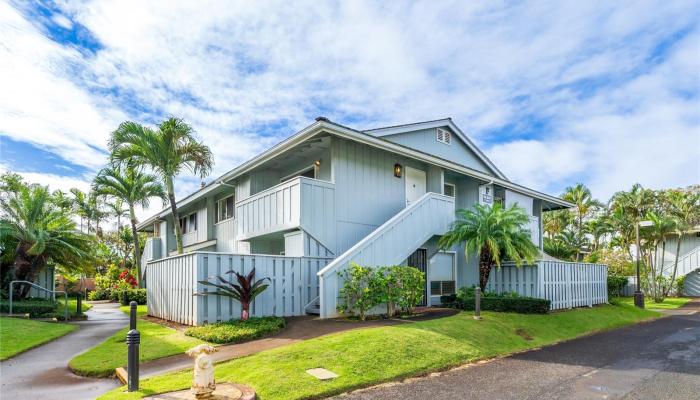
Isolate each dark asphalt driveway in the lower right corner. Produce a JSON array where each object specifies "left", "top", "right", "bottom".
[{"left": 341, "top": 300, "right": 700, "bottom": 400}]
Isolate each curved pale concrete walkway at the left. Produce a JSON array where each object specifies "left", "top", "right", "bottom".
[{"left": 0, "top": 303, "right": 129, "bottom": 400}]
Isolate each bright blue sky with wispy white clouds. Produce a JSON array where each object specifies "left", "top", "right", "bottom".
[{"left": 0, "top": 0, "right": 700, "bottom": 222}]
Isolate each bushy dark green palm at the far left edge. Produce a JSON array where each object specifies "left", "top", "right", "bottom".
[{"left": 0, "top": 185, "right": 92, "bottom": 299}]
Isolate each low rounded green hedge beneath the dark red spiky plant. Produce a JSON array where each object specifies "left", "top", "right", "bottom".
[{"left": 185, "top": 317, "right": 286, "bottom": 344}]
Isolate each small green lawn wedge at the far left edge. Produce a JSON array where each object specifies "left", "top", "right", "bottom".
[{"left": 0, "top": 318, "right": 76, "bottom": 360}]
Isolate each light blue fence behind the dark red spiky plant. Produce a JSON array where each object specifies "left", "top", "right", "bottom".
[{"left": 146, "top": 252, "right": 332, "bottom": 325}]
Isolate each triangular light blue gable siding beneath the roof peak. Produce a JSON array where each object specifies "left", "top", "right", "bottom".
[{"left": 382, "top": 127, "right": 494, "bottom": 174}]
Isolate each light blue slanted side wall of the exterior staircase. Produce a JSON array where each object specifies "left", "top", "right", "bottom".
[{"left": 318, "top": 193, "right": 455, "bottom": 318}]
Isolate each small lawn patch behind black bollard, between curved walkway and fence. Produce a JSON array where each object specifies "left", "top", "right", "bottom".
[{"left": 68, "top": 320, "right": 204, "bottom": 377}]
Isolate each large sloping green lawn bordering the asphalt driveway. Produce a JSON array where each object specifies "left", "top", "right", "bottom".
[{"left": 100, "top": 305, "right": 660, "bottom": 400}]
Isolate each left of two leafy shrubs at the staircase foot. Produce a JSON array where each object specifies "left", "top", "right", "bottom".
[{"left": 338, "top": 263, "right": 381, "bottom": 321}]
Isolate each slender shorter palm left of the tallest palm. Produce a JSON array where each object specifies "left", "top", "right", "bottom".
[{"left": 92, "top": 164, "right": 165, "bottom": 286}]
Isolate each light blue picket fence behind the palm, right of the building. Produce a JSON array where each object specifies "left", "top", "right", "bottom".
[{"left": 486, "top": 261, "right": 608, "bottom": 310}]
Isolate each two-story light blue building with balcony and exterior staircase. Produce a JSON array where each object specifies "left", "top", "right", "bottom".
[{"left": 138, "top": 117, "right": 607, "bottom": 324}]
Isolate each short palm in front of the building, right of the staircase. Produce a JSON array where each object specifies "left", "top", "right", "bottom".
[{"left": 438, "top": 203, "right": 539, "bottom": 290}]
